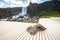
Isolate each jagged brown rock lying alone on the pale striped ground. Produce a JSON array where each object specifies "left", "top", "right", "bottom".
[{"left": 26, "top": 24, "right": 46, "bottom": 35}]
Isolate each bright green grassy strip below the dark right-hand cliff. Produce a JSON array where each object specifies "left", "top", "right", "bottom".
[{"left": 35, "top": 11, "right": 60, "bottom": 18}]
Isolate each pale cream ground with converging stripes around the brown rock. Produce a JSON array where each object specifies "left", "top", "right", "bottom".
[{"left": 0, "top": 19, "right": 60, "bottom": 40}]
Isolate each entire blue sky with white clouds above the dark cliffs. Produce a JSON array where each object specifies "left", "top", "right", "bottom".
[{"left": 0, "top": 0, "right": 48, "bottom": 8}]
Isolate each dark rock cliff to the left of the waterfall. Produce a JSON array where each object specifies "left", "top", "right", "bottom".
[{"left": 0, "top": 7, "right": 22, "bottom": 18}]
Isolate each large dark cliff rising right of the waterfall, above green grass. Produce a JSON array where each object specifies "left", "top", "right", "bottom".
[{"left": 27, "top": 1, "right": 60, "bottom": 16}]
